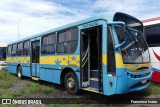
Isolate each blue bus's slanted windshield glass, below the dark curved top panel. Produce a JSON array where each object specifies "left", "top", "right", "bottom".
[{"left": 121, "top": 27, "right": 149, "bottom": 63}]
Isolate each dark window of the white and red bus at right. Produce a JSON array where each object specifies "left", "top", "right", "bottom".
[{"left": 145, "top": 25, "right": 160, "bottom": 47}]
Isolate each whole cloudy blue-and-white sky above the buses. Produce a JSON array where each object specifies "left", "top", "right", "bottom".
[{"left": 0, "top": 0, "right": 160, "bottom": 44}]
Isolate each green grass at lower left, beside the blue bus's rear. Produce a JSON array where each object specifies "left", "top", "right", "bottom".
[{"left": 0, "top": 69, "right": 54, "bottom": 98}]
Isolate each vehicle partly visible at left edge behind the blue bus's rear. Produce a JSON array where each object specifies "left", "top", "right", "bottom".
[{"left": 0, "top": 44, "right": 7, "bottom": 70}]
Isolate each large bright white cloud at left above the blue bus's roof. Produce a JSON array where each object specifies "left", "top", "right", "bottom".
[{"left": 0, "top": 0, "right": 90, "bottom": 42}]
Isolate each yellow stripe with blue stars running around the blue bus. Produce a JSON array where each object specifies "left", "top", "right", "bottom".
[{"left": 6, "top": 53, "right": 150, "bottom": 71}]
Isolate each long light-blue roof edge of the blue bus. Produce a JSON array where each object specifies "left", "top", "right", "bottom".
[{"left": 7, "top": 12, "right": 132, "bottom": 44}]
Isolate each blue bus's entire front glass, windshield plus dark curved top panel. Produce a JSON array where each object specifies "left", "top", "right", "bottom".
[{"left": 115, "top": 14, "right": 150, "bottom": 63}]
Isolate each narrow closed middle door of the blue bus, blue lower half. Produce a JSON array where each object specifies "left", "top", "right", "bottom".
[{"left": 31, "top": 40, "right": 40, "bottom": 77}]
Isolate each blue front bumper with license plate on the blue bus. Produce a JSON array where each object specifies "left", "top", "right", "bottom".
[{"left": 116, "top": 71, "right": 152, "bottom": 94}]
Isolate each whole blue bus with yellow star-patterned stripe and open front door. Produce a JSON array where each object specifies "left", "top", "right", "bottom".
[{"left": 7, "top": 12, "right": 152, "bottom": 96}]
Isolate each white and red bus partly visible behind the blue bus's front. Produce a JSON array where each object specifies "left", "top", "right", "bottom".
[{"left": 142, "top": 17, "right": 160, "bottom": 82}]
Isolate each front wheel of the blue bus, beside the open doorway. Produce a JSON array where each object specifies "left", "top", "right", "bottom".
[{"left": 64, "top": 72, "right": 79, "bottom": 95}]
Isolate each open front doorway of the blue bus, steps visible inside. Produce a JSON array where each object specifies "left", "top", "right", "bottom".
[{"left": 81, "top": 26, "right": 102, "bottom": 92}]
